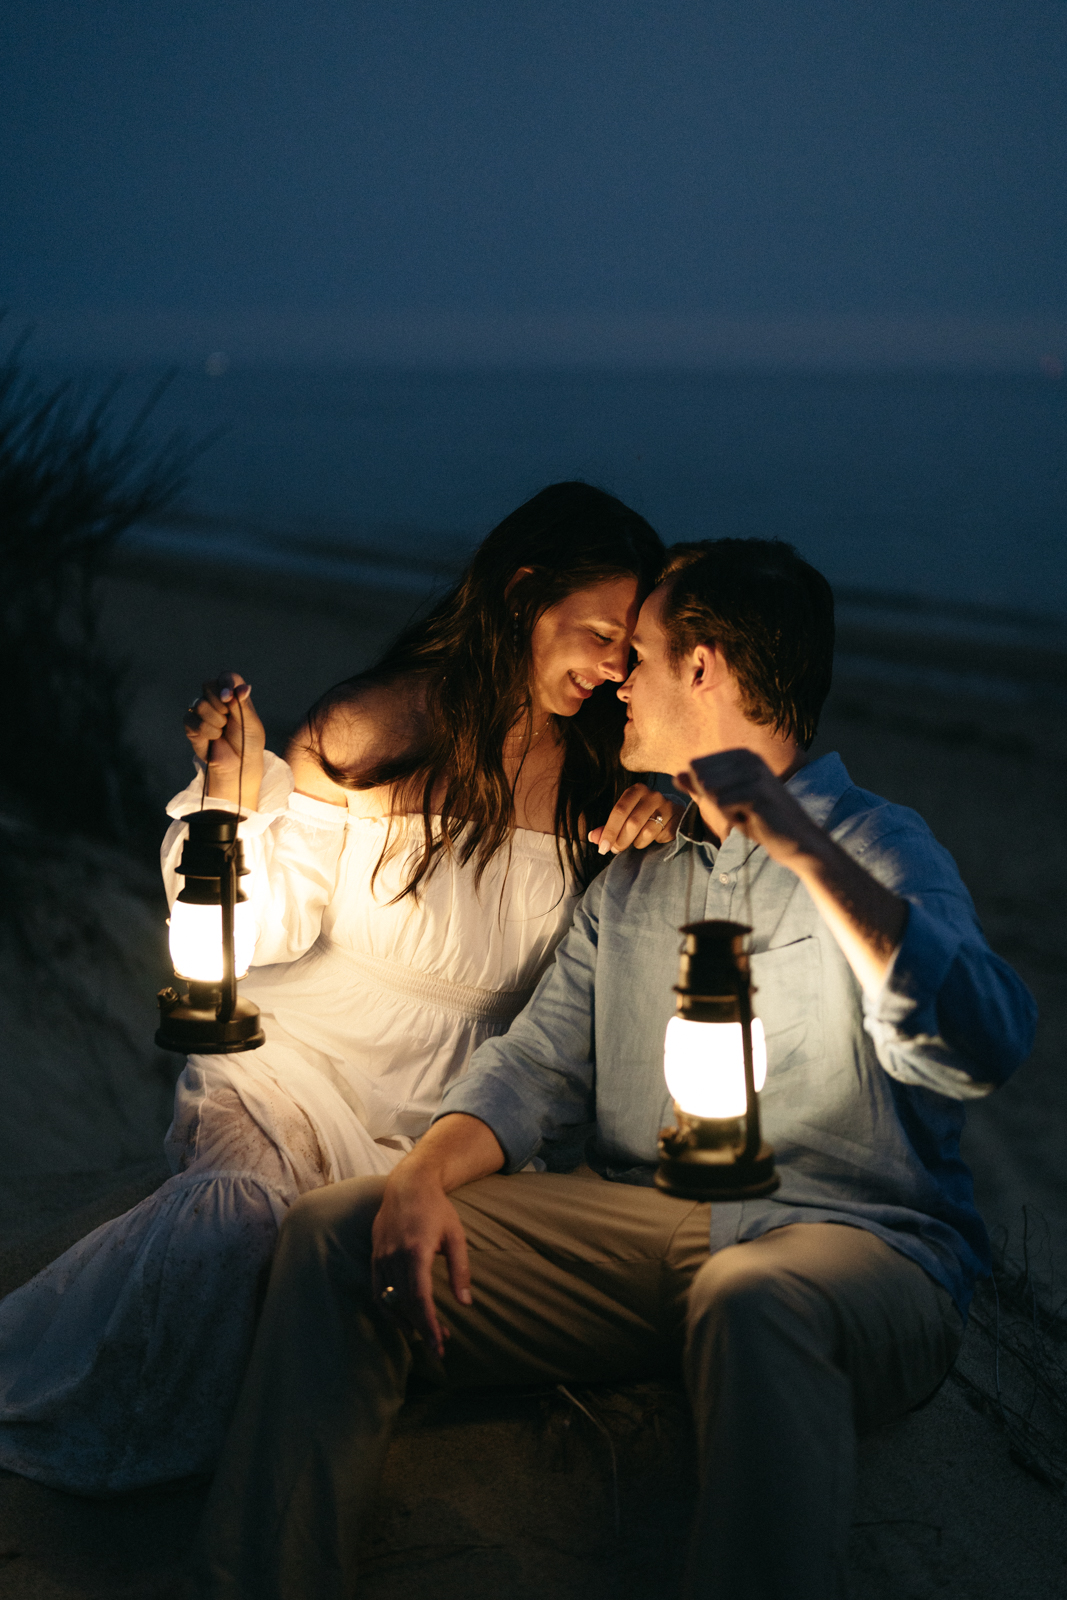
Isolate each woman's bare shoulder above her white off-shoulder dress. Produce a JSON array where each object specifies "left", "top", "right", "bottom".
[{"left": 286, "top": 677, "right": 426, "bottom": 805}]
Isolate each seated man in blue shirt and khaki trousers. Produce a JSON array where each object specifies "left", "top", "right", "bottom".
[{"left": 195, "top": 539, "right": 1033, "bottom": 1600}]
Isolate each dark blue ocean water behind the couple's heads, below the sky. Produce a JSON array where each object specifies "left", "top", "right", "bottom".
[{"left": 131, "top": 368, "right": 1067, "bottom": 634}]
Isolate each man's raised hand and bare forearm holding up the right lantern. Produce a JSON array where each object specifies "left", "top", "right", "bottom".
[{"left": 675, "top": 750, "right": 907, "bottom": 992}]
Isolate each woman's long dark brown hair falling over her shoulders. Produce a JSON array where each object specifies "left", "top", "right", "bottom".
[{"left": 309, "top": 483, "right": 665, "bottom": 898}]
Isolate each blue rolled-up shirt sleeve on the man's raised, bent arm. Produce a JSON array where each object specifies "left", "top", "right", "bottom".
[{"left": 846, "top": 827, "right": 1037, "bottom": 1099}]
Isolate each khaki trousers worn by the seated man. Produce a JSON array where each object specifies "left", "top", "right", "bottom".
[{"left": 200, "top": 1171, "right": 960, "bottom": 1600}]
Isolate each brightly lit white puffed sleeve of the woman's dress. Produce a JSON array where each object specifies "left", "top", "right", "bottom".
[{"left": 160, "top": 750, "right": 349, "bottom": 966}]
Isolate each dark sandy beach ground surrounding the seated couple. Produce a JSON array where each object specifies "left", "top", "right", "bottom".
[{"left": 0, "top": 566, "right": 1067, "bottom": 1600}]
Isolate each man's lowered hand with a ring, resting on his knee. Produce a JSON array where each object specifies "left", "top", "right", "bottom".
[{"left": 371, "top": 1112, "right": 504, "bottom": 1360}]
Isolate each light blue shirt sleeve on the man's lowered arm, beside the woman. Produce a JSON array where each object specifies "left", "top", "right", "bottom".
[{"left": 434, "top": 875, "right": 603, "bottom": 1173}]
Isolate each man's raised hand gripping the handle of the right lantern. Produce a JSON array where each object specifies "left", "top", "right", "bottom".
[{"left": 675, "top": 750, "right": 825, "bottom": 866}]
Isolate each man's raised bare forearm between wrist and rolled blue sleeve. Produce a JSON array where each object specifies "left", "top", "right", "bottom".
[{"left": 789, "top": 830, "right": 907, "bottom": 990}]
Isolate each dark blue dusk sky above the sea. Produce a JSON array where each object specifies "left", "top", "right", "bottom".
[{"left": 0, "top": 0, "right": 1067, "bottom": 366}]
